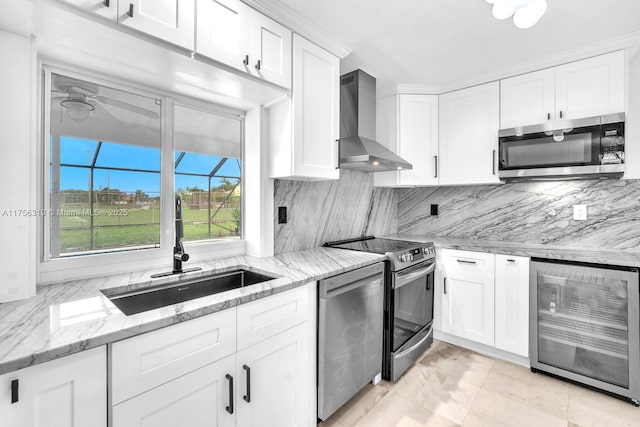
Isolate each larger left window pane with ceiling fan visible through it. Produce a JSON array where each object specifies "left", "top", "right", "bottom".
[{"left": 48, "top": 73, "right": 161, "bottom": 259}]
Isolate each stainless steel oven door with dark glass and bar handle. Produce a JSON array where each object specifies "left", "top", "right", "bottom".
[{"left": 389, "top": 260, "right": 435, "bottom": 381}]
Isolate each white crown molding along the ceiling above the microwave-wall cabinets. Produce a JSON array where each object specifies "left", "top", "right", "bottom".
[{"left": 440, "top": 31, "right": 640, "bottom": 94}]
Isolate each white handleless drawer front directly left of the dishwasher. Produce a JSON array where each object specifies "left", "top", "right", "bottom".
[{"left": 238, "top": 285, "right": 315, "bottom": 350}]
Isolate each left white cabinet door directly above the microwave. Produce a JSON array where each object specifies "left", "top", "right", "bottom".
[{"left": 500, "top": 68, "right": 555, "bottom": 129}]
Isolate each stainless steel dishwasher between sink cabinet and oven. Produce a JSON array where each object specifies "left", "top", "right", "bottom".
[{"left": 318, "top": 263, "right": 384, "bottom": 420}]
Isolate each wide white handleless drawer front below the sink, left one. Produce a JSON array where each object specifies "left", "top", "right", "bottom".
[{"left": 111, "top": 308, "right": 236, "bottom": 405}]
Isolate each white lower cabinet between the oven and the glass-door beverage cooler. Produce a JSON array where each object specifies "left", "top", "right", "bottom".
[{"left": 439, "top": 249, "right": 529, "bottom": 357}]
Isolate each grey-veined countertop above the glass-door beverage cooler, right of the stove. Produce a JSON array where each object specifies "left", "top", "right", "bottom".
[{"left": 385, "top": 234, "right": 640, "bottom": 267}]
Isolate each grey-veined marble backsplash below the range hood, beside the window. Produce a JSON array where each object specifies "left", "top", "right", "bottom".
[{"left": 274, "top": 170, "right": 398, "bottom": 254}]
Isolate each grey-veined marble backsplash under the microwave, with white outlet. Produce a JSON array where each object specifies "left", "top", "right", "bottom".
[{"left": 396, "top": 180, "right": 640, "bottom": 250}]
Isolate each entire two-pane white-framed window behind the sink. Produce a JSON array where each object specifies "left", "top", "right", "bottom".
[{"left": 40, "top": 66, "right": 244, "bottom": 274}]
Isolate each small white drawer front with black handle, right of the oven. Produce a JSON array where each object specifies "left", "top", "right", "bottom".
[{"left": 442, "top": 249, "right": 495, "bottom": 281}]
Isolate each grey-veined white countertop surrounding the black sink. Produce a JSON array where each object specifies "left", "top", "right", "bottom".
[{"left": 0, "top": 248, "right": 384, "bottom": 374}]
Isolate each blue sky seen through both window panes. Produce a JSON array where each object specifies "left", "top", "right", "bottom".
[{"left": 60, "top": 137, "right": 240, "bottom": 196}]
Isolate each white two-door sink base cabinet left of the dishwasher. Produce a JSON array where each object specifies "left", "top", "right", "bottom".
[{"left": 111, "top": 283, "right": 316, "bottom": 427}]
